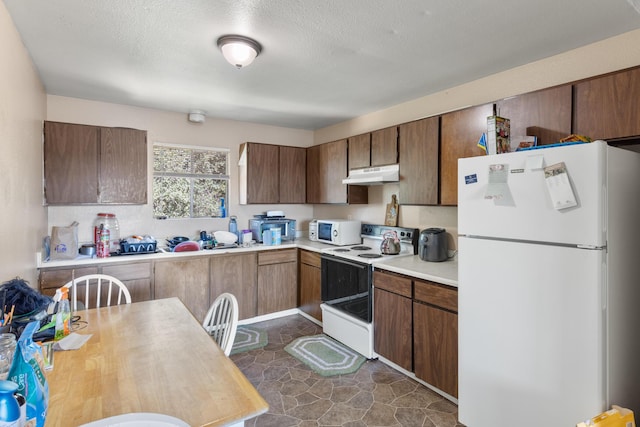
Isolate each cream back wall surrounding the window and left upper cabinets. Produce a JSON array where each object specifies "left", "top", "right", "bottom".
[{"left": 47, "top": 95, "right": 313, "bottom": 242}]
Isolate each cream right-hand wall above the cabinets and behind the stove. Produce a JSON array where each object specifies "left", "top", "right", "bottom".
[{"left": 314, "top": 30, "right": 640, "bottom": 246}]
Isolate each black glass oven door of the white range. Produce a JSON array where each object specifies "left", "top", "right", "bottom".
[{"left": 320, "top": 255, "right": 373, "bottom": 323}]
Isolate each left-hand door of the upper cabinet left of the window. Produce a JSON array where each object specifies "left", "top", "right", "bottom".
[{"left": 44, "top": 122, "right": 100, "bottom": 204}]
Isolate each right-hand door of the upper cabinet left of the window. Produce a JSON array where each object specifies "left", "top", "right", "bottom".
[{"left": 99, "top": 128, "right": 147, "bottom": 204}]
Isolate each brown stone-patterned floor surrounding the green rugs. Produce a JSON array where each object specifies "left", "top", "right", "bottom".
[{"left": 231, "top": 315, "right": 463, "bottom": 427}]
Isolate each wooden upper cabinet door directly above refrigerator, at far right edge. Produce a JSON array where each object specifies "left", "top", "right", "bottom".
[{"left": 573, "top": 68, "right": 640, "bottom": 139}]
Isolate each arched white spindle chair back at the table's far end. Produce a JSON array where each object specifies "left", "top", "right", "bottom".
[{"left": 64, "top": 274, "right": 131, "bottom": 311}]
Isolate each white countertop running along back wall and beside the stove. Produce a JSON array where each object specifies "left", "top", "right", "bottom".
[{"left": 36, "top": 237, "right": 458, "bottom": 287}]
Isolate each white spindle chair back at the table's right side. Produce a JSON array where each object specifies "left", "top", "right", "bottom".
[{"left": 202, "top": 293, "right": 238, "bottom": 356}]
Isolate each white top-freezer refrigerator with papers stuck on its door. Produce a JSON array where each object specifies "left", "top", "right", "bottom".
[{"left": 458, "top": 141, "right": 640, "bottom": 427}]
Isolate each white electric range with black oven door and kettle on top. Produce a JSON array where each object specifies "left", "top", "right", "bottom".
[{"left": 320, "top": 224, "right": 419, "bottom": 359}]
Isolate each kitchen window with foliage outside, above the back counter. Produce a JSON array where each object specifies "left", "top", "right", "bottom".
[{"left": 153, "top": 143, "right": 229, "bottom": 219}]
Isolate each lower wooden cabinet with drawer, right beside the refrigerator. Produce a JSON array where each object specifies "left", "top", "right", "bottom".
[{"left": 413, "top": 281, "right": 458, "bottom": 397}]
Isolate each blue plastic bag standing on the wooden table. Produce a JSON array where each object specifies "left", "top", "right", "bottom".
[{"left": 7, "top": 321, "right": 49, "bottom": 427}]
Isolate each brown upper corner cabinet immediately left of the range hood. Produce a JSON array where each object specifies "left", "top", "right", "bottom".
[{"left": 307, "top": 139, "right": 368, "bottom": 203}]
